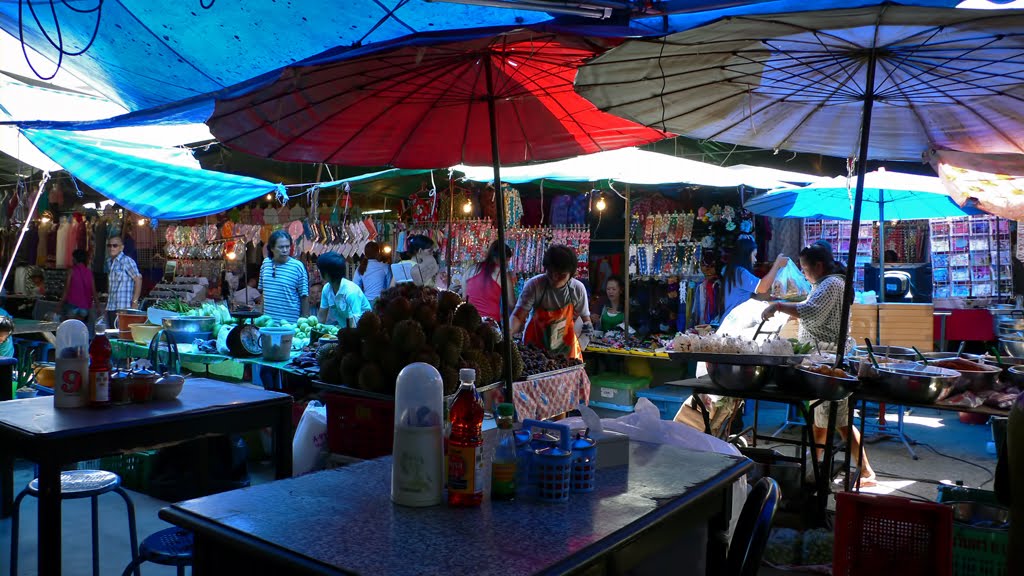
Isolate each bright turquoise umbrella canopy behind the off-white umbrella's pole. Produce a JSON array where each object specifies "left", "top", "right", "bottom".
[{"left": 743, "top": 171, "right": 980, "bottom": 221}]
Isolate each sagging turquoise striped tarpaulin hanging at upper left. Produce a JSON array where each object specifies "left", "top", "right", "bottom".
[{"left": 23, "top": 129, "right": 285, "bottom": 220}]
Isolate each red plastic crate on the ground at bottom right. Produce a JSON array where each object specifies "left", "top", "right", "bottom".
[{"left": 833, "top": 492, "right": 953, "bottom": 576}]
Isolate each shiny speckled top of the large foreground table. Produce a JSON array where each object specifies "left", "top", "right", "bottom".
[{"left": 161, "top": 443, "right": 753, "bottom": 576}]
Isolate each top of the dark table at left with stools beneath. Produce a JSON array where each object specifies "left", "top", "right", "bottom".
[{"left": 0, "top": 378, "right": 292, "bottom": 438}]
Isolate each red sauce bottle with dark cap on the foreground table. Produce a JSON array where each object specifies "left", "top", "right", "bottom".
[{"left": 445, "top": 368, "right": 483, "bottom": 506}]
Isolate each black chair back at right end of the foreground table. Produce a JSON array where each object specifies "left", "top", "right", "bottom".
[{"left": 725, "top": 477, "right": 780, "bottom": 576}]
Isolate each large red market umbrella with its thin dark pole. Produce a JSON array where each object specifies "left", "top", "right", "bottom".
[{"left": 208, "top": 30, "right": 666, "bottom": 398}]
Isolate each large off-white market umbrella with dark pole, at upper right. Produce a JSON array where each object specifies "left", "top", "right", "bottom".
[{"left": 577, "top": 4, "right": 1024, "bottom": 357}]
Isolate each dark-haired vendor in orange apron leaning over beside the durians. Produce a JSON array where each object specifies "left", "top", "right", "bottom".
[{"left": 510, "top": 244, "right": 594, "bottom": 360}]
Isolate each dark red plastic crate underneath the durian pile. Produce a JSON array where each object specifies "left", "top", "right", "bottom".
[{"left": 323, "top": 392, "right": 394, "bottom": 459}]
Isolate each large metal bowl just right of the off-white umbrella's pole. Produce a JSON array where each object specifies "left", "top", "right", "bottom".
[{"left": 861, "top": 363, "right": 961, "bottom": 404}]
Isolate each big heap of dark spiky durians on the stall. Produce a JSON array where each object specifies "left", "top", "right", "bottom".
[{"left": 317, "top": 284, "right": 523, "bottom": 395}]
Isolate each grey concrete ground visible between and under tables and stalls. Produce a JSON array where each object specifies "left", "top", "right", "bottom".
[{"left": 0, "top": 403, "right": 995, "bottom": 576}]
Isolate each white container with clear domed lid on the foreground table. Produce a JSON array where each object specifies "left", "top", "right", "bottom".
[{"left": 391, "top": 362, "right": 444, "bottom": 506}]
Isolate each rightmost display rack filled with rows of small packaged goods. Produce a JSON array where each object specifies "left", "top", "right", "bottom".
[{"left": 929, "top": 212, "right": 1013, "bottom": 299}]
